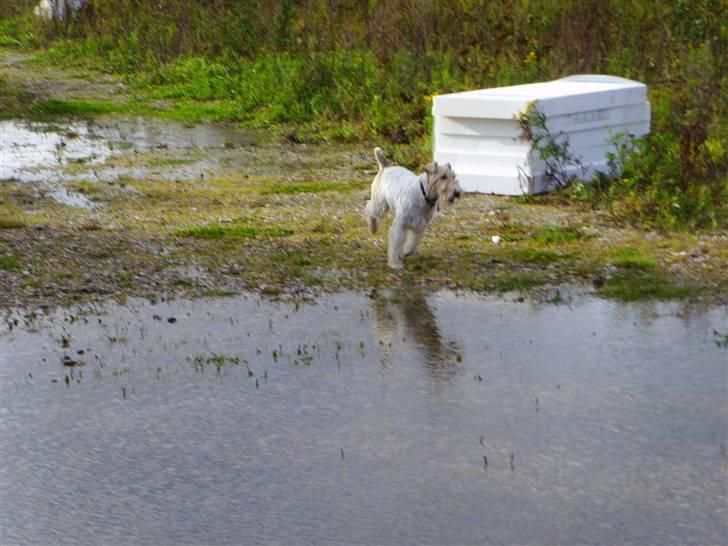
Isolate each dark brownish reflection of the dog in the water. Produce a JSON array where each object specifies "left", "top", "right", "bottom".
[{"left": 372, "top": 287, "right": 459, "bottom": 378}]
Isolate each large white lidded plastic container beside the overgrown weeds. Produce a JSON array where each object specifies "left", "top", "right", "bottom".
[{"left": 432, "top": 75, "right": 650, "bottom": 195}]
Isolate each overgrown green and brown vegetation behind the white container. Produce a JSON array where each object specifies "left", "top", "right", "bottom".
[{"left": 0, "top": 0, "right": 728, "bottom": 228}]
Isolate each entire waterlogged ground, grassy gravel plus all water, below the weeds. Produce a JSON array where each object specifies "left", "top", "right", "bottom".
[{"left": 0, "top": 41, "right": 728, "bottom": 544}]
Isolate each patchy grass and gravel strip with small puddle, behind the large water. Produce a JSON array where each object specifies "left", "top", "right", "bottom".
[{"left": 0, "top": 51, "right": 728, "bottom": 307}]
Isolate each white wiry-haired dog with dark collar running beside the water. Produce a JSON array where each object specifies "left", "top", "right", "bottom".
[{"left": 366, "top": 148, "right": 462, "bottom": 269}]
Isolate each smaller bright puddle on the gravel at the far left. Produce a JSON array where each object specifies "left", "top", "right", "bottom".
[{"left": 0, "top": 118, "right": 262, "bottom": 208}]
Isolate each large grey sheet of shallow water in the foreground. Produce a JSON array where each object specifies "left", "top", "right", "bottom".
[{"left": 0, "top": 291, "right": 728, "bottom": 544}]
